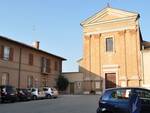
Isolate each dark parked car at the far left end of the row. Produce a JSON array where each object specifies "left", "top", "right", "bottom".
[{"left": 0, "top": 85, "right": 18, "bottom": 103}]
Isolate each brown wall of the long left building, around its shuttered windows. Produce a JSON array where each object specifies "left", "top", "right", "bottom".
[{"left": 0, "top": 39, "right": 62, "bottom": 88}]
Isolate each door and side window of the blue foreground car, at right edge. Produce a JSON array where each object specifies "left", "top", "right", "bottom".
[{"left": 135, "top": 89, "right": 150, "bottom": 113}]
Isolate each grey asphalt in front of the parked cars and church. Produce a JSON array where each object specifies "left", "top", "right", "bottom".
[{"left": 0, "top": 95, "right": 99, "bottom": 113}]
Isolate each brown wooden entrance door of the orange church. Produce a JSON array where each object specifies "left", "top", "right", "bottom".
[{"left": 105, "top": 73, "right": 116, "bottom": 89}]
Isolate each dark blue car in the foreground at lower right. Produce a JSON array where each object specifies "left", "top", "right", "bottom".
[{"left": 97, "top": 88, "right": 150, "bottom": 113}]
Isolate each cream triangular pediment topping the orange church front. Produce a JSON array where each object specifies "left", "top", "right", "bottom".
[{"left": 81, "top": 7, "right": 138, "bottom": 25}]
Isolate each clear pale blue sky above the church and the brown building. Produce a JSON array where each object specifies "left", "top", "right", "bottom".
[{"left": 0, "top": 0, "right": 150, "bottom": 72}]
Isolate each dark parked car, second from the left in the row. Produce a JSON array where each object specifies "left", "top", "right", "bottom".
[{"left": 17, "top": 89, "right": 32, "bottom": 101}]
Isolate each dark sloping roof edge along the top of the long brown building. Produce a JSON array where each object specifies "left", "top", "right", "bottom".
[{"left": 0, "top": 36, "right": 66, "bottom": 60}]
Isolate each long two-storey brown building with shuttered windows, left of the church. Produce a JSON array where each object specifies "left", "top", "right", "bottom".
[{"left": 0, "top": 36, "right": 65, "bottom": 88}]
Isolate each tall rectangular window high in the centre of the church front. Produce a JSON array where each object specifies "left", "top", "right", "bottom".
[{"left": 106, "top": 37, "right": 113, "bottom": 52}]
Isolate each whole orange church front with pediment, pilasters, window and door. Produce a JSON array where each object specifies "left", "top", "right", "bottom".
[{"left": 78, "top": 7, "right": 144, "bottom": 92}]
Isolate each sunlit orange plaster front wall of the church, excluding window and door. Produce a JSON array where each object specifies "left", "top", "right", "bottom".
[{"left": 79, "top": 7, "right": 143, "bottom": 90}]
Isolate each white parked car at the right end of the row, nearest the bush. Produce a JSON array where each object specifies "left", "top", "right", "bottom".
[{"left": 43, "top": 87, "right": 58, "bottom": 98}]
